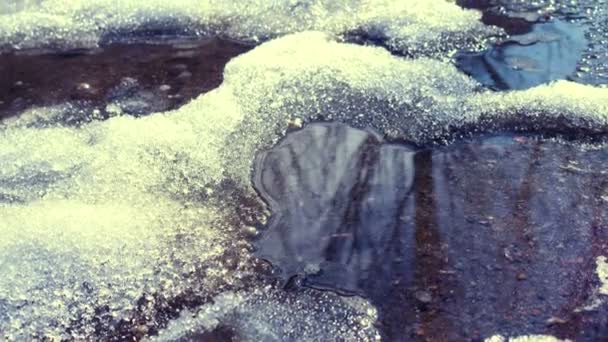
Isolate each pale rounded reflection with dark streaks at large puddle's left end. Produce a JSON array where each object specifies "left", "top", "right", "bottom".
[{"left": 256, "top": 124, "right": 413, "bottom": 295}]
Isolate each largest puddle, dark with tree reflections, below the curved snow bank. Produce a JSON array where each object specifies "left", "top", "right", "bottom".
[{"left": 254, "top": 123, "right": 608, "bottom": 341}]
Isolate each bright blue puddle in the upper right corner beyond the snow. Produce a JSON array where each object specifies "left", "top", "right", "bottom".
[{"left": 457, "top": 0, "right": 608, "bottom": 85}]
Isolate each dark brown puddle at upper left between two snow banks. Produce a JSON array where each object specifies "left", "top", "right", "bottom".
[{"left": 0, "top": 38, "right": 251, "bottom": 121}]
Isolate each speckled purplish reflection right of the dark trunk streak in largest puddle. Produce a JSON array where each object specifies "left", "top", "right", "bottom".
[{"left": 433, "top": 137, "right": 608, "bottom": 338}]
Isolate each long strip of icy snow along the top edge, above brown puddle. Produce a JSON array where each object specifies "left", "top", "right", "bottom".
[{"left": 0, "top": 0, "right": 498, "bottom": 54}]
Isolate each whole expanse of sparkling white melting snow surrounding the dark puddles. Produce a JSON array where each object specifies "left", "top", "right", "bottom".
[{"left": 0, "top": 0, "right": 608, "bottom": 340}]
